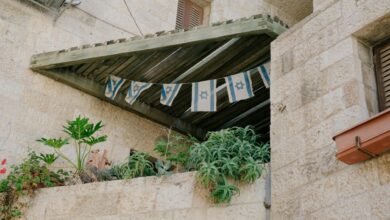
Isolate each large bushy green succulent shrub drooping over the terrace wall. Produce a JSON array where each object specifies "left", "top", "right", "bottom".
[{"left": 187, "top": 127, "right": 270, "bottom": 203}]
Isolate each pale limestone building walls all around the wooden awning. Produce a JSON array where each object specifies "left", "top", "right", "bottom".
[{"left": 0, "top": 0, "right": 390, "bottom": 220}]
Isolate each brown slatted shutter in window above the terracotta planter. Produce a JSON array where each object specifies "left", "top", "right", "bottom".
[{"left": 374, "top": 39, "right": 390, "bottom": 111}]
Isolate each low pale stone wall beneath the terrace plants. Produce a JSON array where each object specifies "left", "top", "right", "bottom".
[{"left": 26, "top": 173, "right": 265, "bottom": 220}]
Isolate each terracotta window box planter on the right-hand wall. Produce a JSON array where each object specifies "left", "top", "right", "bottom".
[{"left": 333, "top": 109, "right": 390, "bottom": 164}]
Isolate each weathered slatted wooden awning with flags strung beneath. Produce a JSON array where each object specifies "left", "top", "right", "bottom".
[{"left": 31, "top": 15, "right": 285, "bottom": 137}]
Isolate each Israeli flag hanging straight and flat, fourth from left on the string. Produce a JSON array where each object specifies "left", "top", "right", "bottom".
[{"left": 191, "top": 79, "right": 217, "bottom": 112}]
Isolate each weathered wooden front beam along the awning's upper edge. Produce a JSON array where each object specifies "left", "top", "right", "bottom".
[{"left": 30, "top": 16, "right": 285, "bottom": 70}]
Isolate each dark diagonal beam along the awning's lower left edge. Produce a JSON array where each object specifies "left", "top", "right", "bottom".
[{"left": 37, "top": 70, "right": 206, "bottom": 138}]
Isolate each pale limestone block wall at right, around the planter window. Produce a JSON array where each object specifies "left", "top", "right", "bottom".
[{"left": 271, "top": 0, "right": 390, "bottom": 220}]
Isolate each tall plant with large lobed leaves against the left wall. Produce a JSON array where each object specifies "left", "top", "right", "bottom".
[{"left": 38, "top": 116, "right": 107, "bottom": 175}]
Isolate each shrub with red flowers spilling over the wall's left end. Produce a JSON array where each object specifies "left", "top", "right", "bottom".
[{"left": 0, "top": 152, "right": 69, "bottom": 220}]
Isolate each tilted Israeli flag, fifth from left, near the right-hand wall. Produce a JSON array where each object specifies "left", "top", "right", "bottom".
[{"left": 225, "top": 72, "right": 254, "bottom": 103}]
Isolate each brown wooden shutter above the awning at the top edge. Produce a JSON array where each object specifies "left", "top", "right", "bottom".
[{"left": 176, "top": 0, "right": 203, "bottom": 29}]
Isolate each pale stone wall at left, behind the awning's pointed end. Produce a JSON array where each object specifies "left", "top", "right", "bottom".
[{"left": 0, "top": 0, "right": 176, "bottom": 164}]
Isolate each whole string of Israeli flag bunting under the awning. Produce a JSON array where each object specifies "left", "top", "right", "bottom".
[{"left": 105, "top": 62, "right": 270, "bottom": 112}]
